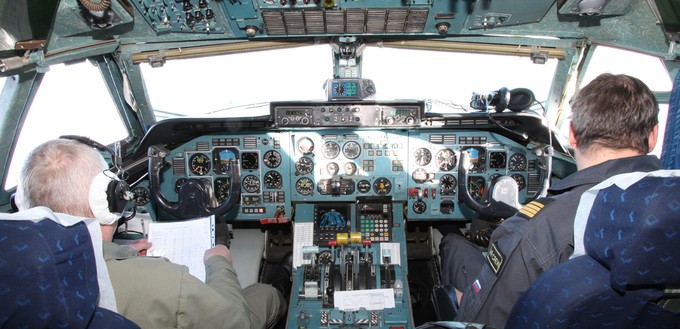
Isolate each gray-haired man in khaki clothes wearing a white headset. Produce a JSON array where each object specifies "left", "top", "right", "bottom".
[{"left": 16, "top": 139, "right": 286, "bottom": 329}]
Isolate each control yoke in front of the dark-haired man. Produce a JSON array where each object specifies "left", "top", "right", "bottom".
[{"left": 458, "top": 145, "right": 553, "bottom": 220}]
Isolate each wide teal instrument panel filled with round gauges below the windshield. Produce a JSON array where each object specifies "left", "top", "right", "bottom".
[{"left": 154, "top": 127, "right": 541, "bottom": 221}]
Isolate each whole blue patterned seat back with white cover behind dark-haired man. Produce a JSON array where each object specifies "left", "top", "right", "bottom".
[{"left": 506, "top": 171, "right": 680, "bottom": 328}]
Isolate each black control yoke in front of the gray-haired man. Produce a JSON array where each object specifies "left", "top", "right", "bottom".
[{"left": 148, "top": 146, "right": 241, "bottom": 219}]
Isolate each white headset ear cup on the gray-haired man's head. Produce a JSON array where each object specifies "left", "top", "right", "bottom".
[{"left": 89, "top": 170, "right": 122, "bottom": 225}]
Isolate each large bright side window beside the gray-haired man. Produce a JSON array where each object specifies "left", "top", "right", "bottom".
[{"left": 0, "top": 61, "right": 128, "bottom": 190}]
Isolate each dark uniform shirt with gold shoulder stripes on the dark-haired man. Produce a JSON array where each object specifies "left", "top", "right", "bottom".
[{"left": 456, "top": 156, "right": 661, "bottom": 328}]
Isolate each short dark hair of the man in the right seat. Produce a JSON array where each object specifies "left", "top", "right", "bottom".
[{"left": 569, "top": 73, "right": 659, "bottom": 154}]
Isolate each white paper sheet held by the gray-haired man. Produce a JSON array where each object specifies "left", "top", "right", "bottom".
[{"left": 147, "top": 216, "right": 215, "bottom": 282}]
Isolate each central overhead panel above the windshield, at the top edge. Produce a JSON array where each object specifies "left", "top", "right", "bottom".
[{"left": 223, "top": 0, "right": 467, "bottom": 38}]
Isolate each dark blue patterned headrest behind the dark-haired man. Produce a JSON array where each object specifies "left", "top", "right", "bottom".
[{"left": 583, "top": 175, "right": 680, "bottom": 292}]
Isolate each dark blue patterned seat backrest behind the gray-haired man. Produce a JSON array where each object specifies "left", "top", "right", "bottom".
[{"left": 0, "top": 219, "right": 139, "bottom": 328}]
